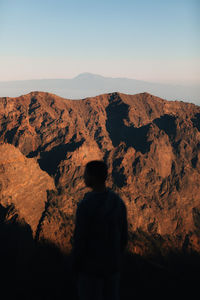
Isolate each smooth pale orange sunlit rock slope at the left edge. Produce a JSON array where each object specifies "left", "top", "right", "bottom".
[{"left": 0, "top": 144, "right": 55, "bottom": 236}]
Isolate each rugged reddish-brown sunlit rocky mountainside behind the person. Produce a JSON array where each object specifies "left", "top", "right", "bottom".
[{"left": 0, "top": 92, "right": 200, "bottom": 254}]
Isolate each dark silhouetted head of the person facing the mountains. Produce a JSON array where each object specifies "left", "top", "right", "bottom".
[{"left": 84, "top": 160, "right": 108, "bottom": 188}]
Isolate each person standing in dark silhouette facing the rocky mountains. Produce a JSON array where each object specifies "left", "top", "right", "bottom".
[{"left": 73, "top": 161, "right": 128, "bottom": 300}]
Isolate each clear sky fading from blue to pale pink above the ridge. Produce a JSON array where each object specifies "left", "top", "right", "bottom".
[{"left": 0, "top": 0, "right": 200, "bottom": 84}]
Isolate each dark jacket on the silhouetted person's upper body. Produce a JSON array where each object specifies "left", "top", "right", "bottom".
[{"left": 73, "top": 190, "right": 128, "bottom": 276}]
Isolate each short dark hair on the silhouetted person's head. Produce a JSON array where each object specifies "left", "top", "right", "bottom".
[{"left": 85, "top": 160, "right": 108, "bottom": 183}]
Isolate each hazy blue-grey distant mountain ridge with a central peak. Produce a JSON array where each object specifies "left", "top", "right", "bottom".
[{"left": 0, "top": 73, "right": 200, "bottom": 105}]
